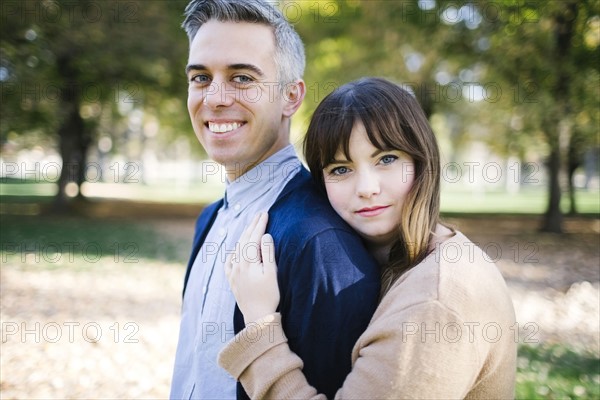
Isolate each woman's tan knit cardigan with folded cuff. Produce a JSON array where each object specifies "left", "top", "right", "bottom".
[{"left": 219, "top": 232, "right": 518, "bottom": 399}]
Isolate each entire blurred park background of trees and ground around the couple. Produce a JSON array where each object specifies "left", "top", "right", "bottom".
[{"left": 0, "top": 0, "right": 600, "bottom": 399}]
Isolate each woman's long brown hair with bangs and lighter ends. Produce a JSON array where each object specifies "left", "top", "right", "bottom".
[{"left": 304, "top": 78, "right": 440, "bottom": 295}]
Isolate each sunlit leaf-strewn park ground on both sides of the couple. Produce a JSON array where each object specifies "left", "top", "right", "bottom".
[{"left": 0, "top": 215, "right": 600, "bottom": 399}]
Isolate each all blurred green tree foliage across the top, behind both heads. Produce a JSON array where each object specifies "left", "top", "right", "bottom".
[{"left": 0, "top": 0, "right": 600, "bottom": 222}]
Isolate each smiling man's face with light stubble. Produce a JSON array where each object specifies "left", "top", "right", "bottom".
[{"left": 187, "top": 20, "right": 295, "bottom": 180}]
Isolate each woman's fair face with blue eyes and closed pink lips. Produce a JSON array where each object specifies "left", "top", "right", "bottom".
[{"left": 323, "top": 121, "right": 414, "bottom": 245}]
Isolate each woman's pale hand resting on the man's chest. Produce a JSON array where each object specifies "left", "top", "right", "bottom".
[{"left": 225, "top": 213, "right": 279, "bottom": 325}]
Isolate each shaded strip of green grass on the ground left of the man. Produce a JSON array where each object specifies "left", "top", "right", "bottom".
[{"left": 0, "top": 215, "right": 191, "bottom": 269}]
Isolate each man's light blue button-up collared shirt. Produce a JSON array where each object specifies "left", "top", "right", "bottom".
[{"left": 170, "top": 145, "right": 301, "bottom": 399}]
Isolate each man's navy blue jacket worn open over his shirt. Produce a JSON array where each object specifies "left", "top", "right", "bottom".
[{"left": 184, "top": 168, "right": 380, "bottom": 399}]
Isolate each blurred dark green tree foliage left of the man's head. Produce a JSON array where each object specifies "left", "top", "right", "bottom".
[{"left": 0, "top": 0, "right": 187, "bottom": 148}]
